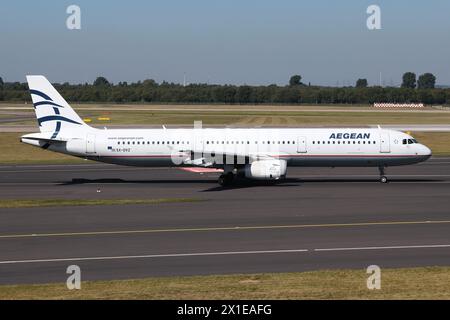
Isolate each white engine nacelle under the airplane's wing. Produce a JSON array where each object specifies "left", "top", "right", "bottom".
[{"left": 245, "top": 160, "right": 287, "bottom": 180}]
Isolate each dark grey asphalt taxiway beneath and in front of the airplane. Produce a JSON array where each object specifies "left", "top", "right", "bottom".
[{"left": 0, "top": 158, "right": 450, "bottom": 284}]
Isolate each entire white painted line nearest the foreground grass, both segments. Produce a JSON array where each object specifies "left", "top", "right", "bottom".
[{"left": 0, "top": 244, "right": 450, "bottom": 265}]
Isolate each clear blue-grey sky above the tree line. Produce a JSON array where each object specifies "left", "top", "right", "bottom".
[{"left": 0, "top": 0, "right": 450, "bottom": 86}]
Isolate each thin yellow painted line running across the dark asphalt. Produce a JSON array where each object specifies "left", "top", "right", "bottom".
[{"left": 0, "top": 220, "right": 450, "bottom": 239}]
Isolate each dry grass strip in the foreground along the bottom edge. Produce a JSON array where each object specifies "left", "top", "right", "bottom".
[{"left": 0, "top": 267, "right": 450, "bottom": 299}]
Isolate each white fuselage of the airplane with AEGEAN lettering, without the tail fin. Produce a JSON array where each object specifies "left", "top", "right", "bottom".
[{"left": 43, "top": 128, "right": 431, "bottom": 167}]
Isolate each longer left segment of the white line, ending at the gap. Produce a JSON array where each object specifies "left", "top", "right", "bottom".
[{"left": 0, "top": 249, "right": 309, "bottom": 264}]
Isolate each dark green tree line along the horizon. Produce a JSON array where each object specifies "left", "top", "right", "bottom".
[{"left": 0, "top": 72, "right": 450, "bottom": 104}]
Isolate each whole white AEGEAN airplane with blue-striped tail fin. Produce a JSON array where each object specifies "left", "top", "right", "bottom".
[{"left": 21, "top": 75, "right": 431, "bottom": 186}]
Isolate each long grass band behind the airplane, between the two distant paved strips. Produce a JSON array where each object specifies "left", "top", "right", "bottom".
[{"left": 8, "top": 110, "right": 450, "bottom": 127}]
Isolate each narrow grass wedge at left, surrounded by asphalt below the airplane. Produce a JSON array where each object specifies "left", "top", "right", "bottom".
[{"left": 0, "top": 198, "right": 204, "bottom": 208}]
